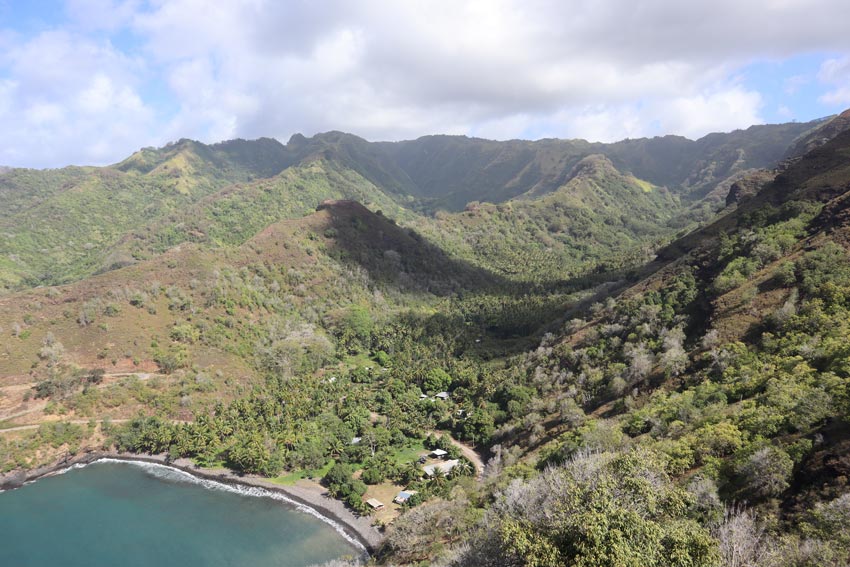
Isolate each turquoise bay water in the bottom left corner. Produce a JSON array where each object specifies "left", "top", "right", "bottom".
[{"left": 0, "top": 462, "right": 360, "bottom": 567}]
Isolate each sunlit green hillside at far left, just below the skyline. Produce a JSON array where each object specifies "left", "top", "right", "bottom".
[{"left": 0, "top": 140, "right": 292, "bottom": 288}]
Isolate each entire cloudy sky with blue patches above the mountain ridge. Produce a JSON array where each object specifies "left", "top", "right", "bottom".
[{"left": 0, "top": 0, "right": 850, "bottom": 168}]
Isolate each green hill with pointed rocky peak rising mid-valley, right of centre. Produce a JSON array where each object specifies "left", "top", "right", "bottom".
[{"left": 414, "top": 155, "right": 681, "bottom": 283}]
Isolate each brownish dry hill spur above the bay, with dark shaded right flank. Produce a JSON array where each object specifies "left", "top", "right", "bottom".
[{"left": 0, "top": 201, "right": 490, "bottom": 425}]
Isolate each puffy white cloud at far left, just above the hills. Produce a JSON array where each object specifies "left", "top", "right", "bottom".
[{"left": 0, "top": 31, "right": 155, "bottom": 166}]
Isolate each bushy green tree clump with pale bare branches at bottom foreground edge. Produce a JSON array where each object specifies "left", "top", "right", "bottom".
[{"left": 455, "top": 451, "right": 718, "bottom": 567}]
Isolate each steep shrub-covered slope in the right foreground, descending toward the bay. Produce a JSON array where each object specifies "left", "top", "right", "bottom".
[{"left": 418, "top": 112, "right": 850, "bottom": 567}]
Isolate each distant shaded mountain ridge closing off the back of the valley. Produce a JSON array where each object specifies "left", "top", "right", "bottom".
[{"left": 296, "top": 117, "right": 823, "bottom": 211}]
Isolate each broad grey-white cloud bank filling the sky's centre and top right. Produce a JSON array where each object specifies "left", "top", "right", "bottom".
[{"left": 126, "top": 0, "right": 850, "bottom": 146}]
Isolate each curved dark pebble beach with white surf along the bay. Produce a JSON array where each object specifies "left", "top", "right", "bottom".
[{"left": 0, "top": 451, "right": 384, "bottom": 554}]
